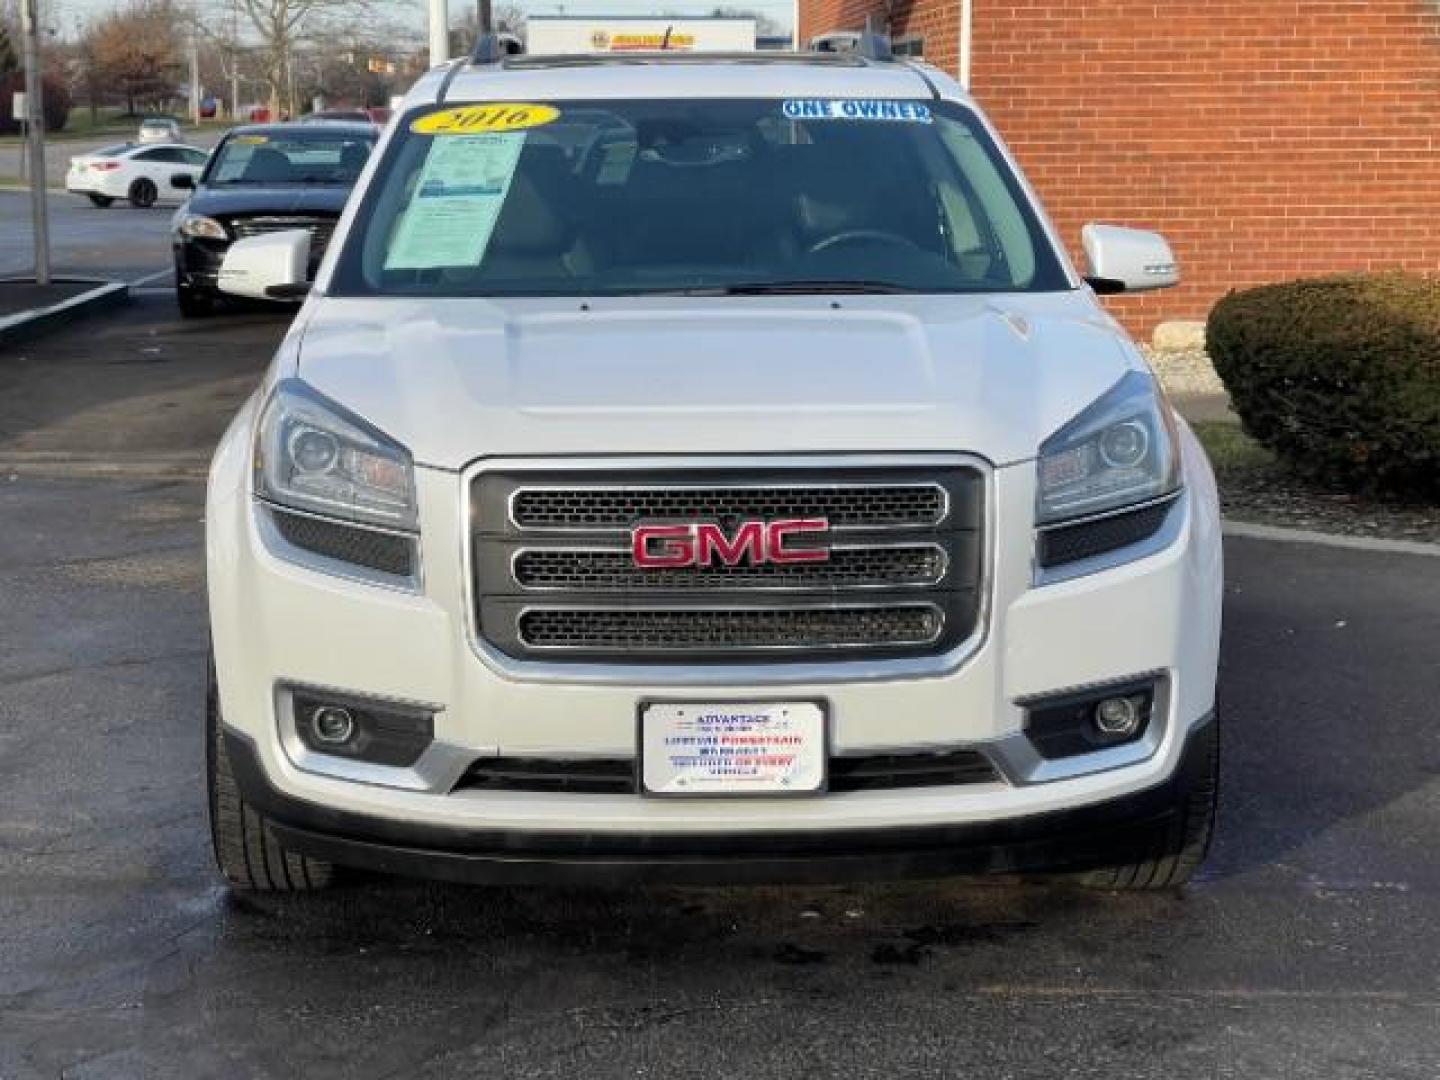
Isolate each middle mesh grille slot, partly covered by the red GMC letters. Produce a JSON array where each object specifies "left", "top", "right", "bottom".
[{"left": 514, "top": 544, "right": 945, "bottom": 592}]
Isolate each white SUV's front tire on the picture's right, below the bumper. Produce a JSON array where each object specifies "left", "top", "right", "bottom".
[{"left": 1076, "top": 713, "right": 1220, "bottom": 891}]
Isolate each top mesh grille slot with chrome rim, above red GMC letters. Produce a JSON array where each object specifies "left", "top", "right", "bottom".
[{"left": 513, "top": 484, "right": 946, "bottom": 528}]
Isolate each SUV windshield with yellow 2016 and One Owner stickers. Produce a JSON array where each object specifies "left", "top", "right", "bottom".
[{"left": 330, "top": 99, "right": 1070, "bottom": 297}]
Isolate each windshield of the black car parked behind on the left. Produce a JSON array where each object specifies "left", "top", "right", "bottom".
[{"left": 204, "top": 128, "right": 374, "bottom": 187}]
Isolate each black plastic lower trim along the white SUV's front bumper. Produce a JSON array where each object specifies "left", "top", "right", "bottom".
[{"left": 225, "top": 717, "right": 1215, "bottom": 884}]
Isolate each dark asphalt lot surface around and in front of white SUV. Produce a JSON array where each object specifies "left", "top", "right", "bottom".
[{"left": 0, "top": 295, "right": 1440, "bottom": 1079}]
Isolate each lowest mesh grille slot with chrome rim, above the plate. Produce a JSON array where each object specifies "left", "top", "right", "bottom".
[{"left": 520, "top": 603, "right": 945, "bottom": 652}]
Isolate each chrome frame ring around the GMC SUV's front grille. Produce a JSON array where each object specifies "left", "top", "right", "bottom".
[{"left": 455, "top": 452, "right": 996, "bottom": 687}]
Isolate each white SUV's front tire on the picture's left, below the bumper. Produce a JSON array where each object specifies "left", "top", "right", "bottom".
[{"left": 204, "top": 655, "right": 336, "bottom": 893}]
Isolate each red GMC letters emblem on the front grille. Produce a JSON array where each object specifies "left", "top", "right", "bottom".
[{"left": 631, "top": 517, "right": 829, "bottom": 569}]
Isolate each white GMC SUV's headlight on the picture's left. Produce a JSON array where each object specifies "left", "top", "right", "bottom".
[{"left": 255, "top": 379, "right": 419, "bottom": 530}]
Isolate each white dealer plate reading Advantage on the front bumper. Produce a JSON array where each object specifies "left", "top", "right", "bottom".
[{"left": 639, "top": 701, "right": 827, "bottom": 796}]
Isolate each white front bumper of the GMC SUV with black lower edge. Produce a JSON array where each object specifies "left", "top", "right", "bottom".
[{"left": 207, "top": 406, "right": 1220, "bottom": 880}]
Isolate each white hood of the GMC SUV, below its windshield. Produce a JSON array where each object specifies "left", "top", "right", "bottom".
[{"left": 298, "top": 291, "right": 1142, "bottom": 469}]
